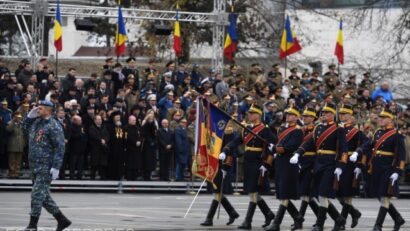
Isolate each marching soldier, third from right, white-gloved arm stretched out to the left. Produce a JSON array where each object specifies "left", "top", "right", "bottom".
[{"left": 290, "top": 103, "right": 348, "bottom": 231}]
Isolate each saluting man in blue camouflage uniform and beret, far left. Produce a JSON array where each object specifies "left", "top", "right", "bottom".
[{"left": 23, "top": 101, "right": 71, "bottom": 231}]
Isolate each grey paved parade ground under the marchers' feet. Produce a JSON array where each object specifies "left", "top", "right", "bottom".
[{"left": 0, "top": 192, "right": 410, "bottom": 230}]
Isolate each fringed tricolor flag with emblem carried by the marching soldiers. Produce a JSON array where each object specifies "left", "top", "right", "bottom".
[{"left": 192, "top": 98, "right": 231, "bottom": 188}]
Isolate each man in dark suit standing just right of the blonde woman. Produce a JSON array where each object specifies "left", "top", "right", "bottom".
[{"left": 158, "top": 119, "right": 174, "bottom": 181}]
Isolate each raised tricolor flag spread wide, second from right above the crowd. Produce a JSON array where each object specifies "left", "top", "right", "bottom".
[{"left": 279, "top": 16, "right": 302, "bottom": 59}]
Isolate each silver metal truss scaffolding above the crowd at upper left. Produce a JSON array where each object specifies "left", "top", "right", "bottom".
[{"left": 0, "top": 0, "right": 228, "bottom": 72}]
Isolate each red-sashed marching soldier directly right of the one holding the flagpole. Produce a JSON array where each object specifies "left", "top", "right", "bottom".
[{"left": 266, "top": 107, "right": 303, "bottom": 231}]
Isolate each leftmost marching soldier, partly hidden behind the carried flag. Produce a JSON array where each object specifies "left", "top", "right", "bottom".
[{"left": 201, "top": 123, "right": 239, "bottom": 226}]
